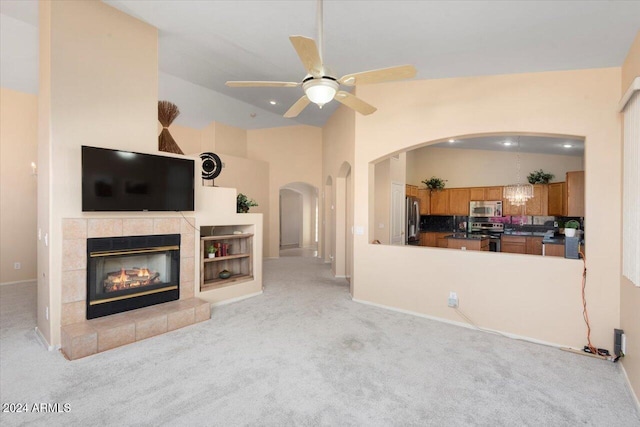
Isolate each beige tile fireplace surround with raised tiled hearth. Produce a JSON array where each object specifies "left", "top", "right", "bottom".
[{"left": 61, "top": 218, "right": 211, "bottom": 360}]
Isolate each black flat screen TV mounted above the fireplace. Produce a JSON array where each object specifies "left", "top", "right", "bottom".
[{"left": 82, "top": 146, "right": 194, "bottom": 212}]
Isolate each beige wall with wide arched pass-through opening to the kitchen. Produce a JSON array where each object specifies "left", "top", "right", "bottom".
[{"left": 352, "top": 68, "right": 621, "bottom": 348}]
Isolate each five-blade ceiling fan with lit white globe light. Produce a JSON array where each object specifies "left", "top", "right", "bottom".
[{"left": 226, "top": 0, "right": 416, "bottom": 118}]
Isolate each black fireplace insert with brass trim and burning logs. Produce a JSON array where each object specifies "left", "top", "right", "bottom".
[{"left": 87, "top": 234, "right": 180, "bottom": 319}]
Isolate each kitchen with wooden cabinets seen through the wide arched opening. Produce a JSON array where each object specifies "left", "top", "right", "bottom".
[{"left": 378, "top": 135, "right": 585, "bottom": 259}]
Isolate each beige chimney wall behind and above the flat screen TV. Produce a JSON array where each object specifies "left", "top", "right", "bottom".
[{"left": 38, "top": 1, "right": 158, "bottom": 345}]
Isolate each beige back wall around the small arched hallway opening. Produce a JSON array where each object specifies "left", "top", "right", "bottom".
[{"left": 247, "top": 126, "right": 322, "bottom": 258}]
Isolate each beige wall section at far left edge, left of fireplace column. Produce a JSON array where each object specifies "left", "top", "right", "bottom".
[{"left": 0, "top": 88, "right": 38, "bottom": 284}]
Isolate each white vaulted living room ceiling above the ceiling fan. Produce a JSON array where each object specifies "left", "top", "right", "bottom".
[{"left": 0, "top": 0, "right": 640, "bottom": 129}]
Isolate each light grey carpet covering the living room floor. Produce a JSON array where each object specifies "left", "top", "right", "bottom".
[{"left": 0, "top": 257, "right": 640, "bottom": 426}]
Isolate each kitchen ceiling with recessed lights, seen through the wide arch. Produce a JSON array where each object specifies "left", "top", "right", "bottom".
[{"left": 430, "top": 134, "right": 584, "bottom": 157}]
